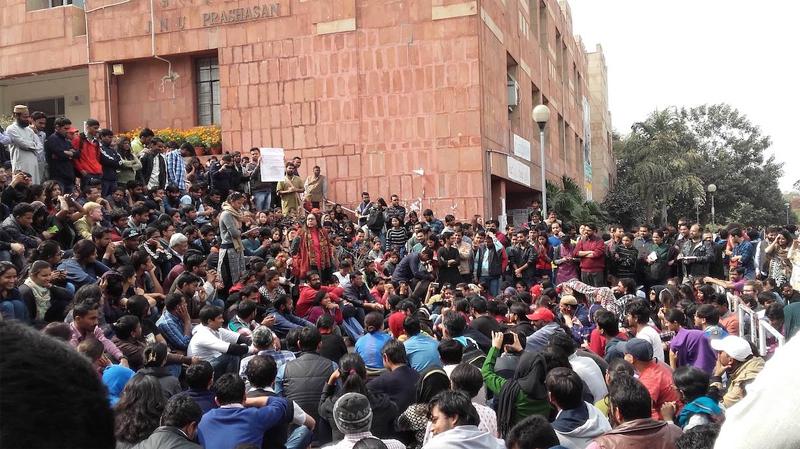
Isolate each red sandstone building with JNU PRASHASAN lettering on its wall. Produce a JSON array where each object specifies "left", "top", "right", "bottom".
[{"left": 0, "top": 0, "right": 613, "bottom": 218}]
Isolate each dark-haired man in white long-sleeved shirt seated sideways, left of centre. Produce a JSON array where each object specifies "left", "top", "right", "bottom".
[{"left": 186, "top": 306, "right": 250, "bottom": 378}]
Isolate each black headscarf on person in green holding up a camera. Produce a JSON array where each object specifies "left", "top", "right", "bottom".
[{"left": 497, "top": 352, "right": 547, "bottom": 437}]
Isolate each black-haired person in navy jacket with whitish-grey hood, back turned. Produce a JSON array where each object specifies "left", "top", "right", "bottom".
[{"left": 545, "top": 368, "right": 611, "bottom": 449}]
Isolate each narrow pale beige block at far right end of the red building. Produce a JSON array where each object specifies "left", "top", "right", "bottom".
[{"left": 586, "top": 44, "right": 617, "bottom": 202}]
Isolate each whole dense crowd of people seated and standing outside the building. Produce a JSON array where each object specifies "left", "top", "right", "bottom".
[{"left": 0, "top": 106, "right": 800, "bottom": 449}]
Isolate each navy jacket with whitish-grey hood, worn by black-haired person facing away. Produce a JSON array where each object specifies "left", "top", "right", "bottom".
[{"left": 553, "top": 402, "right": 611, "bottom": 449}]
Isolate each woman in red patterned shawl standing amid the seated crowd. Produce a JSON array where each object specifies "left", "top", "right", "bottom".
[{"left": 292, "top": 214, "right": 333, "bottom": 284}]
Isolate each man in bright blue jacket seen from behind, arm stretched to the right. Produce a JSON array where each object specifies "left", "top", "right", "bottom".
[{"left": 197, "top": 373, "right": 292, "bottom": 449}]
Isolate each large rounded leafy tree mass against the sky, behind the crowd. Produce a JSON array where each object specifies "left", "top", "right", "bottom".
[{"left": 605, "top": 104, "right": 786, "bottom": 227}]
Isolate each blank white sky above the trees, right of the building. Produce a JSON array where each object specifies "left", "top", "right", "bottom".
[{"left": 569, "top": 0, "right": 800, "bottom": 191}]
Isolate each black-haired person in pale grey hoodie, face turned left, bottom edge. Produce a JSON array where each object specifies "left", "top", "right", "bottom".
[{"left": 422, "top": 390, "right": 505, "bottom": 449}]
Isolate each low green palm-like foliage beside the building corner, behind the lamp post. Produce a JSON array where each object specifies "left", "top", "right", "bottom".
[{"left": 547, "top": 176, "right": 609, "bottom": 226}]
